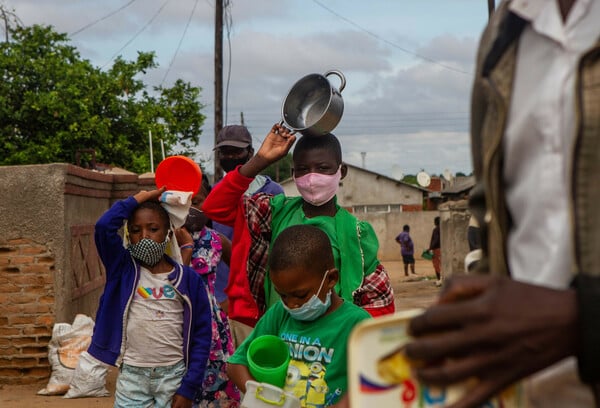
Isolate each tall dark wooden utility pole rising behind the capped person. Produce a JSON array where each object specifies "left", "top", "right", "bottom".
[{"left": 214, "top": 0, "right": 227, "bottom": 181}]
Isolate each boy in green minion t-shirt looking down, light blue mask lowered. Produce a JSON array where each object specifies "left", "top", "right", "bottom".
[{"left": 227, "top": 225, "right": 370, "bottom": 407}]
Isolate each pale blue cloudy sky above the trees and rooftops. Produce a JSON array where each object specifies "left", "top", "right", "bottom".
[{"left": 8, "top": 0, "right": 487, "bottom": 176}]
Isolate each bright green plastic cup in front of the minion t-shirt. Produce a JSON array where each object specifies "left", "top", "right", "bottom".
[{"left": 246, "top": 335, "right": 290, "bottom": 388}]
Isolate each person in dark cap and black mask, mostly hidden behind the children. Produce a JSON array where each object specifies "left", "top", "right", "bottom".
[{"left": 213, "top": 125, "right": 283, "bottom": 347}]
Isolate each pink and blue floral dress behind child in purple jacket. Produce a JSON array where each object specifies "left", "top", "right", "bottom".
[{"left": 191, "top": 227, "right": 240, "bottom": 408}]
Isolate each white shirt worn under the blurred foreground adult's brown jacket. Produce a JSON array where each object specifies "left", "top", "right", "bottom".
[{"left": 503, "top": 0, "right": 600, "bottom": 407}]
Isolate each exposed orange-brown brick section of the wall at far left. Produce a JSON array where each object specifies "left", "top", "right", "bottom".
[{"left": 0, "top": 238, "right": 55, "bottom": 384}]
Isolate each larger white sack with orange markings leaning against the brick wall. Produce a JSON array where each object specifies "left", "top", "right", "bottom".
[{"left": 38, "top": 314, "right": 94, "bottom": 395}]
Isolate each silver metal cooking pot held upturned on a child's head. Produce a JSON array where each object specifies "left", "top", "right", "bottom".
[{"left": 281, "top": 70, "right": 346, "bottom": 136}]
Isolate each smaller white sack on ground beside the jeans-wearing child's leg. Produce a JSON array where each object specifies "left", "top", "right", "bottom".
[{"left": 64, "top": 351, "right": 110, "bottom": 398}]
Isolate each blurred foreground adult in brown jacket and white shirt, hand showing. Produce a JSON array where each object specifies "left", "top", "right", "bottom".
[{"left": 406, "top": 0, "right": 600, "bottom": 407}]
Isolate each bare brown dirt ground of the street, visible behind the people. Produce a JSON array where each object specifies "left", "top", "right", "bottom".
[{"left": 0, "top": 259, "right": 439, "bottom": 408}]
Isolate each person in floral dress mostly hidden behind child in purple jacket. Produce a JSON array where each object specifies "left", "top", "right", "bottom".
[{"left": 175, "top": 173, "right": 240, "bottom": 408}]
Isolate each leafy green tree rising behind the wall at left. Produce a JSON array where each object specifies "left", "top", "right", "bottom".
[{"left": 0, "top": 25, "right": 205, "bottom": 173}]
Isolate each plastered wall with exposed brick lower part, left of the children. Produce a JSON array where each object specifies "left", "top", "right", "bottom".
[{"left": 0, "top": 163, "right": 154, "bottom": 385}]
